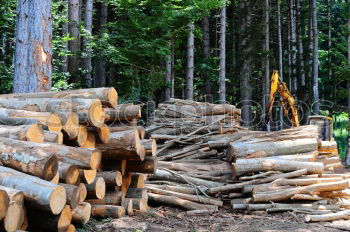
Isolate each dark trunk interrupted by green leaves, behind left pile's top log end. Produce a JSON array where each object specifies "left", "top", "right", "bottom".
[{"left": 95, "top": 1, "right": 108, "bottom": 87}]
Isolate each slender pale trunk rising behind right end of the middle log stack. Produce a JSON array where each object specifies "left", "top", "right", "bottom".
[{"left": 219, "top": 0, "right": 226, "bottom": 103}]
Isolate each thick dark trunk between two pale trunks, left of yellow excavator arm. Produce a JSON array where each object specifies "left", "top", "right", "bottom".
[{"left": 238, "top": 0, "right": 252, "bottom": 126}]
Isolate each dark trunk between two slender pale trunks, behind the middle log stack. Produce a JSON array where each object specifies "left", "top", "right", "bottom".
[{"left": 202, "top": 16, "right": 211, "bottom": 100}]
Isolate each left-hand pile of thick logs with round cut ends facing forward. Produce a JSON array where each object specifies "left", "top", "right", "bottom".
[{"left": 0, "top": 88, "right": 157, "bottom": 231}]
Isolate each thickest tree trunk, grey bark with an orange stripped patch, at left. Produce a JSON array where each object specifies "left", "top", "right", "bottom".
[{"left": 13, "top": 0, "right": 52, "bottom": 93}]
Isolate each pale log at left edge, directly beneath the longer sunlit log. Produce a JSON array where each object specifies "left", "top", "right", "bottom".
[{"left": 0, "top": 124, "right": 44, "bottom": 143}]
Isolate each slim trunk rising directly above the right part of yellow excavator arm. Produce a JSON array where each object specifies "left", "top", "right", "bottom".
[{"left": 289, "top": 0, "right": 297, "bottom": 93}]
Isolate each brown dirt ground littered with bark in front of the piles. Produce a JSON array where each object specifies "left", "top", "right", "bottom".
[{"left": 78, "top": 206, "right": 350, "bottom": 232}]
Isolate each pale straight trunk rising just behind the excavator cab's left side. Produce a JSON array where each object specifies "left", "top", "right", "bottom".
[{"left": 311, "top": 0, "right": 320, "bottom": 114}]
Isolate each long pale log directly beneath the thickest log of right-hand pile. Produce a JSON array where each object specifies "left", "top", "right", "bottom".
[{"left": 232, "top": 158, "right": 324, "bottom": 176}]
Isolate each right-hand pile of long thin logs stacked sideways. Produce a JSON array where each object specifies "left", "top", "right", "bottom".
[{"left": 146, "top": 99, "right": 350, "bottom": 221}]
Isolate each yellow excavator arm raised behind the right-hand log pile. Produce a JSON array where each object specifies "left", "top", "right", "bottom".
[{"left": 268, "top": 70, "right": 300, "bottom": 127}]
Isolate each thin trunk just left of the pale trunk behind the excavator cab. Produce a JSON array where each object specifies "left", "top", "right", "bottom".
[{"left": 296, "top": 0, "right": 306, "bottom": 87}]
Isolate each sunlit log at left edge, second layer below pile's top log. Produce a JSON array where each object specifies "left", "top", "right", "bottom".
[{"left": 0, "top": 108, "right": 62, "bottom": 132}]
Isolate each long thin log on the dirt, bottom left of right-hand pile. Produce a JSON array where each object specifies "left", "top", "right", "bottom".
[{"left": 147, "top": 187, "right": 223, "bottom": 206}]
